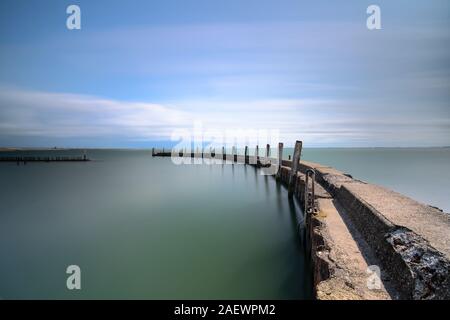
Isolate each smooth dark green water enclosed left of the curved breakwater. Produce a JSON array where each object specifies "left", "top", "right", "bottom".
[{"left": 0, "top": 150, "right": 312, "bottom": 299}]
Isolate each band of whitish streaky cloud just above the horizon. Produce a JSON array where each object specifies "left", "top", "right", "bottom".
[{"left": 0, "top": 88, "right": 450, "bottom": 146}]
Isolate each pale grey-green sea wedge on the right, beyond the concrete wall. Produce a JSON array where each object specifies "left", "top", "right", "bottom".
[{"left": 298, "top": 148, "right": 450, "bottom": 212}]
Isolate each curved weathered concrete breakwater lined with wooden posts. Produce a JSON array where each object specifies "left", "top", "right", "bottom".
[{"left": 153, "top": 142, "right": 450, "bottom": 299}]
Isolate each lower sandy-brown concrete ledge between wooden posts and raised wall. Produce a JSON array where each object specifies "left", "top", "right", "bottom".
[{"left": 316, "top": 199, "right": 397, "bottom": 300}]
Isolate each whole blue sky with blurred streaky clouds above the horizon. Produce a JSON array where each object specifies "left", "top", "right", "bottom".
[{"left": 0, "top": 0, "right": 450, "bottom": 148}]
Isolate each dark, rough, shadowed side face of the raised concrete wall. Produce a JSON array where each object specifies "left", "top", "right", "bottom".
[{"left": 300, "top": 162, "right": 450, "bottom": 299}]
